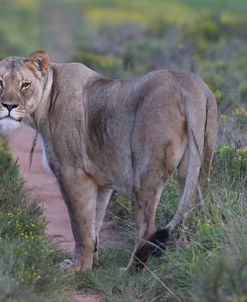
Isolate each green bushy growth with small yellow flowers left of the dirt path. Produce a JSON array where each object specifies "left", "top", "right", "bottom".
[{"left": 0, "top": 138, "right": 69, "bottom": 302}]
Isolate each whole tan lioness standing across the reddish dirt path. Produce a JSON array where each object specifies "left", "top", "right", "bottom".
[{"left": 0, "top": 51, "right": 217, "bottom": 270}]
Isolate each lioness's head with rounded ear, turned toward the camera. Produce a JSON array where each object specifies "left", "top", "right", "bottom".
[{"left": 0, "top": 51, "right": 49, "bottom": 128}]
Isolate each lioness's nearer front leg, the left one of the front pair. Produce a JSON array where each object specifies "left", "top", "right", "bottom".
[{"left": 58, "top": 167, "right": 97, "bottom": 270}]
